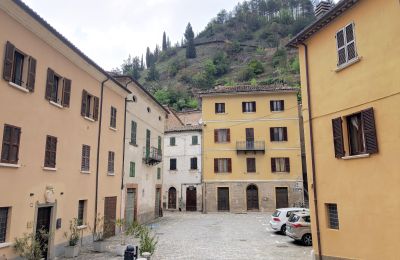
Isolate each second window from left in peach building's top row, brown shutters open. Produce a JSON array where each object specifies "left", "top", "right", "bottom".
[{"left": 45, "top": 68, "right": 71, "bottom": 107}]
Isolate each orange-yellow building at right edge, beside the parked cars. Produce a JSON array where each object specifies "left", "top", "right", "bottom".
[{"left": 289, "top": 0, "right": 400, "bottom": 259}]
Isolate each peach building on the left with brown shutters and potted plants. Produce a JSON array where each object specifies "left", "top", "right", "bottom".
[{"left": 0, "top": 1, "right": 129, "bottom": 258}]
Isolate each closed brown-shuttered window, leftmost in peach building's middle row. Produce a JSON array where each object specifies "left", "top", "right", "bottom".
[{"left": 1, "top": 125, "right": 21, "bottom": 164}]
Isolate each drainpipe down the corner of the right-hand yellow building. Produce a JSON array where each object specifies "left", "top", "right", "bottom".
[{"left": 301, "top": 43, "right": 322, "bottom": 260}]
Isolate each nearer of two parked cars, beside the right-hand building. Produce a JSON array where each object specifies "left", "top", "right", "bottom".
[{"left": 286, "top": 211, "right": 312, "bottom": 246}]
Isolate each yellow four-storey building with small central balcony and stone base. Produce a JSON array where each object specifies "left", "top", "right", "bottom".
[{"left": 200, "top": 85, "right": 303, "bottom": 212}]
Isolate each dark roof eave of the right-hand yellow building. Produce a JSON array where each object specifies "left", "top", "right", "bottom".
[{"left": 286, "top": 0, "right": 359, "bottom": 47}]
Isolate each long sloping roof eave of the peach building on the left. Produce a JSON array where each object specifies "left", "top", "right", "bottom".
[{"left": 13, "top": 0, "right": 131, "bottom": 93}]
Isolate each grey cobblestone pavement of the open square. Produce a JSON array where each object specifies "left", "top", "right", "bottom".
[{"left": 57, "top": 212, "right": 312, "bottom": 260}]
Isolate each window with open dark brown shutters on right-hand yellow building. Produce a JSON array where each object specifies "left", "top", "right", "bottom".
[{"left": 332, "top": 108, "right": 378, "bottom": 158}]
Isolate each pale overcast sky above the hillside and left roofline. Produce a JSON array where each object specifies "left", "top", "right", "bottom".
[{"left": 23, "top": 0, "right": 239, "bottom": 70}]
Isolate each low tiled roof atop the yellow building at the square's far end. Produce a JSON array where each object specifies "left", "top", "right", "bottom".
[{"left": 198, "top": 84, "right": 299, "bottom": 96}]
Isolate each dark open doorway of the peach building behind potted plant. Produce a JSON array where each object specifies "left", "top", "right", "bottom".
[{"left": 36, "top": 207, "right": 52, "bottom": 259}]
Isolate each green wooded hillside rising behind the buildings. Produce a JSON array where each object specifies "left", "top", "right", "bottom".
[{"left": 112, "top": 0, "right": 315, "bottom": 110}]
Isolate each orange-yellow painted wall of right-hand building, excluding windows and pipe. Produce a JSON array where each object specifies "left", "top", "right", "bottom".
[{"left": 299, "top": 0, "right": 400, "bottom": 259}]
